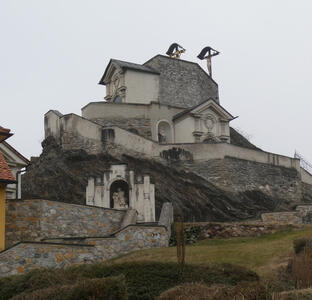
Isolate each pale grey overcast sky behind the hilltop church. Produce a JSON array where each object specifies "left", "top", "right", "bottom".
[{"left": 0, "top": 0, "right": 312, "bottom": 161}]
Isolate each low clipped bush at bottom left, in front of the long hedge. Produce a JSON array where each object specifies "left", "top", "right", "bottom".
[{"left": 12, "top": 276, "right": 128, "bottom": 300}]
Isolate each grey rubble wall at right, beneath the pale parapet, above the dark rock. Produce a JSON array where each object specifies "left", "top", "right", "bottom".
[{"left": 188, "top": 156, "right": 302, "bottom": 205}]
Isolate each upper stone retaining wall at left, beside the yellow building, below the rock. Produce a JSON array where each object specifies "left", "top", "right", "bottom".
[{"left": 6, "top": 199, "right": 125, "bottom": 247}]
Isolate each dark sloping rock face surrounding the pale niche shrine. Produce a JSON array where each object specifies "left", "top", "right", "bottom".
[{"left": 22, "top": 137, "right": 308, "bottom": 221}]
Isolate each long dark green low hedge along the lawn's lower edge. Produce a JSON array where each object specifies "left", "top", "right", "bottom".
[{"left": 0, "top": 262, "right": 258, "bottom": 300}]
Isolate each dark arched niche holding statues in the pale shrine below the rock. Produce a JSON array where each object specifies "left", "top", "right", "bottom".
[{"left": 109, "top": 180, "right": 129, "bottom": 209}]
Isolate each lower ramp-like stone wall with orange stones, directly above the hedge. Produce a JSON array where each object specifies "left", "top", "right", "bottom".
[{"left": 0, "top": 225, "right": 168, "bottom": 277}]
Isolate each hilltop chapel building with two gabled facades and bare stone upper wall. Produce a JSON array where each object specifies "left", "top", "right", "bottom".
[{"left": 86, "top": 50, "right": 234, "bottom": 144}]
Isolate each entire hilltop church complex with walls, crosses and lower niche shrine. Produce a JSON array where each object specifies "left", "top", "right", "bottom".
[{"left": 45, "top": 44, "right": 312, "bottom": 222}]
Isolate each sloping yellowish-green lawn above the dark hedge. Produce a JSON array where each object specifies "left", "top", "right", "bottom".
[{"left": 114, "top": 226, "right": 312, "bottom": 275}]
